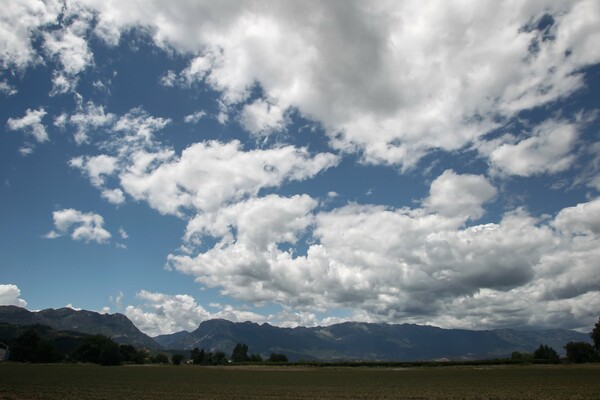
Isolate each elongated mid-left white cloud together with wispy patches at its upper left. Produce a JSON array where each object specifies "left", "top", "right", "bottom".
[{"left": 63, "top": 103, "right": 339, "bottom": 216}]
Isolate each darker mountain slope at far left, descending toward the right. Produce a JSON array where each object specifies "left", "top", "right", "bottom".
[{"left": 0, "top": 306, "right": 160, "bottom": 349}]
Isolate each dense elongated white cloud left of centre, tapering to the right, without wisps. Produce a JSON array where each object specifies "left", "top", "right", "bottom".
[{"left": 120, "top": 141, "right": 339, "bottom": 215}]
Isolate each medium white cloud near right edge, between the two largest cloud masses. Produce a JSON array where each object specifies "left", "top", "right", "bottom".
[{"left": 489, "top": 120, "right": 578, "bottom": 176}]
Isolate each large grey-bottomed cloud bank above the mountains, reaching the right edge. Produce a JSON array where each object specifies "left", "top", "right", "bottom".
[{"left": 168, "top": 171, "right": 600, "bottom": 328}]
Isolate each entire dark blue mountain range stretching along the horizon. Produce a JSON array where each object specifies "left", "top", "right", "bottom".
[{"left": 0, "top": 306, "right": 591, "bottom": 361}]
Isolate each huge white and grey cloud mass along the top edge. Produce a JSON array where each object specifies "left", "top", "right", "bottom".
[{"left": 71, "top": 0, "right": 600, "bottom": 167}]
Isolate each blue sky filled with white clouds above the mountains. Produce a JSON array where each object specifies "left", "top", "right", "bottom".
[{"left": 0, "top": 0, "right": 600, "bottom": 335}]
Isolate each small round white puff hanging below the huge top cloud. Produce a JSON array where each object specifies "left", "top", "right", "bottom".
[{"left": 240, "top": 99, "right": 286, "bottom": 136}]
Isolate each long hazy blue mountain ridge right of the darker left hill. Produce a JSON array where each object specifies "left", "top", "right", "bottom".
[{"left": 155, "top": 320, "right": 590, "bottom": 361}]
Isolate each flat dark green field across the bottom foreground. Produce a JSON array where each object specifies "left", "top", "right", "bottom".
[{"left": 0, "top": 363, "right": 600, "bottom": 400}]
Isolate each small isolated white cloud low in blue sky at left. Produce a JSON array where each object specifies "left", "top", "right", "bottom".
[{"left": 45, "top": 208, "right": 111, "bottom": 244}]
